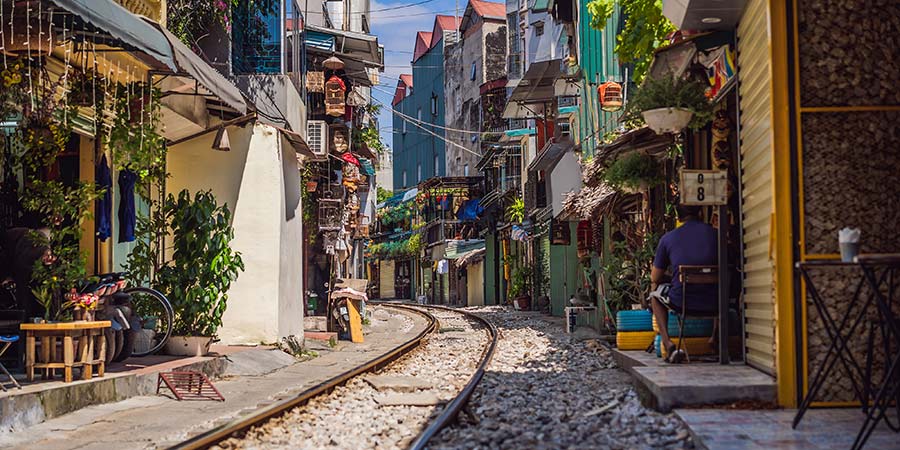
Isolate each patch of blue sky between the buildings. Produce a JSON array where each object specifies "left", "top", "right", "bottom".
[{"left": 370, "top": 0, "right": 466, "bottom": 158}]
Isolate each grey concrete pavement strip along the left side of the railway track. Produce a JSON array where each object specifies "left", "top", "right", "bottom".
[{"left": 0, "top": 306, "right": 425, "bottom": 450}]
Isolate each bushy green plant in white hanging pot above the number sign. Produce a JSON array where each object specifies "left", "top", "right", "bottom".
[{"left": 628, "top": 76, "right": 713, "bottom": 134}]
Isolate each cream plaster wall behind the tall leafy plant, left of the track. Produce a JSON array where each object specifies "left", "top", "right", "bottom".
[{"left": 167, "top": 123, "right": 303, "bottom": 344}]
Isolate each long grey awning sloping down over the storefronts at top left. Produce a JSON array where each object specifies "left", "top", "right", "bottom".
[{"left": 53, "top": 0, "right": 248, "bottom": 114}]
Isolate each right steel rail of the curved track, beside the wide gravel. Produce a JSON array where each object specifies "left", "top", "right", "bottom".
[{"left": 409, "top": 305, "right": 500, "bottom": 450}]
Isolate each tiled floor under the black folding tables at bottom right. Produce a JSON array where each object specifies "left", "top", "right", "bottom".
[{"left": 675, "top": 408, "right": 900, "bottom": 450}]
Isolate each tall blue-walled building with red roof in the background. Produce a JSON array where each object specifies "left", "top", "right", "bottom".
[{"left": 392, "top": 16, "right": 459, "bottom": 190}]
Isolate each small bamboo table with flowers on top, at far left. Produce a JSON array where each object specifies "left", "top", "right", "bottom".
[{"left": 21, "top": 320, "right": 111, "bottom": 383}]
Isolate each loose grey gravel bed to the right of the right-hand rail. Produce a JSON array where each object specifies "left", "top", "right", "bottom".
[{"left": 430, "top": 307, "right": 693, "bottom": 449}]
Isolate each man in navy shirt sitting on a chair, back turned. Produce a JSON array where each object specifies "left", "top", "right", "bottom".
[{"left": 650, "top": 205, "right": 719, "bottom": 363}]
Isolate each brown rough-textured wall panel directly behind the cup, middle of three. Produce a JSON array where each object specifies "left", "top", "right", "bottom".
[{"left": 803, "top": 112, "right": 900, "bottom": 254}]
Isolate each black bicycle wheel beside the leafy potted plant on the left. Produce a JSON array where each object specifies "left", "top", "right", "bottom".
[{"left": 125, "top": 286, "right": 175, "bottom": 356}]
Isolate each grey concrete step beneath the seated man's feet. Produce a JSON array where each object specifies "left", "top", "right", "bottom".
[{"left": 613, "top": 349, "right": 776, "bottom": 412}]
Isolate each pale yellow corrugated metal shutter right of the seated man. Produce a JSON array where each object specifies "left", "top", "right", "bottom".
[{"left": 737, "top": 0, "right": 775, "bottom": 374}]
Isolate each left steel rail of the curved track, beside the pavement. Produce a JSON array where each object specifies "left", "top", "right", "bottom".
[{"left": 169, "top": 302, "right": 439, "bottom": 450}]
